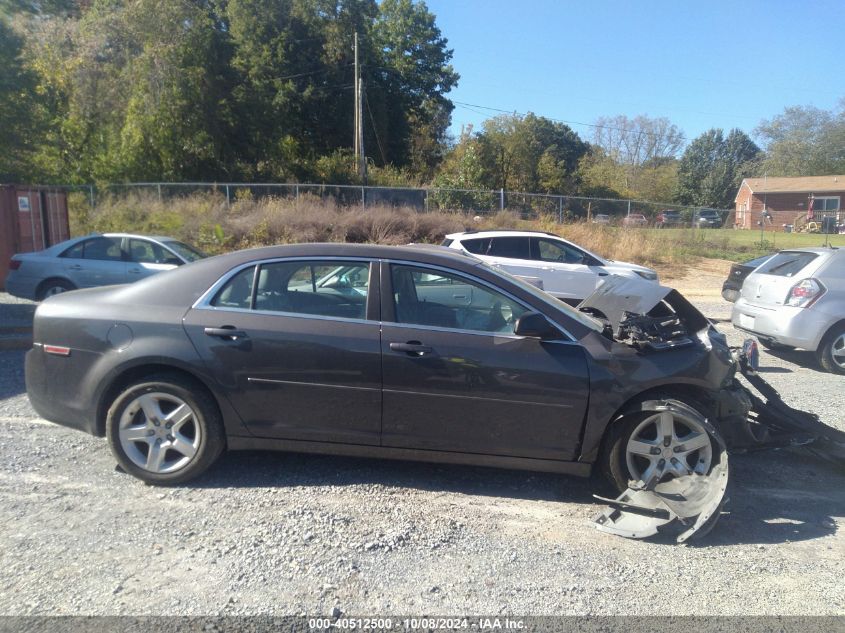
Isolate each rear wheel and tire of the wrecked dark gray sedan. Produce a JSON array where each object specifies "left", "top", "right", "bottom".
[{"left": 106, "top": 374, "right": 226, "bottom": 486}]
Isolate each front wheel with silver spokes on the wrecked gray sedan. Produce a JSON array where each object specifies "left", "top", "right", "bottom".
[{"left": 604, "top": 406, "right": 715, "bottom": 492}]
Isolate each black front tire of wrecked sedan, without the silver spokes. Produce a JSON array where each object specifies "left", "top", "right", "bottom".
[{"left": 602, "top": 398, "right": 718, "bottom": 492}]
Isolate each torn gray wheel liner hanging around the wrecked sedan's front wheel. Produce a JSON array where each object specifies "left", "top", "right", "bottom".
[{"left": 593, "top": 402, "right": 729, "bottom": 543}]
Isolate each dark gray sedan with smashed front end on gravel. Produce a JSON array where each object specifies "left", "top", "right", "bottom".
[{"left": 26, "top": 244, "right": 842, "bottom": 541}]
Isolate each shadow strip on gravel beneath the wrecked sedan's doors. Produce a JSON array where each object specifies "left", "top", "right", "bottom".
[{"left": 192, "top": 451, "right": 607, "bottom": 503}]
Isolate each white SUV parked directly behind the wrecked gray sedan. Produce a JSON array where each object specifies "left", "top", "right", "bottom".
[{"left": 442, "top": 231, "right": 657, "bottom": 304}]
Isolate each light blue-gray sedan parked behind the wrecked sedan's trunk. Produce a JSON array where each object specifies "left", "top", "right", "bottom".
[{"left": 6, "top": 233, "right": 205, "bottom": 301}]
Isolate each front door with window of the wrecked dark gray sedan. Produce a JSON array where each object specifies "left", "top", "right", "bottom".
[{"left": 382, "top": 263, "right": 589, "bottom": 460}]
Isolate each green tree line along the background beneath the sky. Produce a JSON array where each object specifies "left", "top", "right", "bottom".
[{"left": 0, "top": 0, "right": 845, "bottom": 208}]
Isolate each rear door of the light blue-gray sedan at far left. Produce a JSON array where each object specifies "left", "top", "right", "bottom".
[{"left": 61, "top": 236, "right": 126, "bottom": 288}]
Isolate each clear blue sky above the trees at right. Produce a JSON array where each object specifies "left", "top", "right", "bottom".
[{"left": 427, "top": 0, "right": 845, "bottom": 146}]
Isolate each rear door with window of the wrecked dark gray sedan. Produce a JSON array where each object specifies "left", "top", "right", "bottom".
[{"left": 184, "top": 259, "right": 382, "bottom": 445}]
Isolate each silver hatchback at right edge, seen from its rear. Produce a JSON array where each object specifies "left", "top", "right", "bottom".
[{"left": 731, "top": 247, "right": 845, "bottom": 374}]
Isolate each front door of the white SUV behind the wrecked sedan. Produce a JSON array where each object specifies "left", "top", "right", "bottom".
[{"left": 531, "top": 237, "right": 607, "bottom": 301}]
